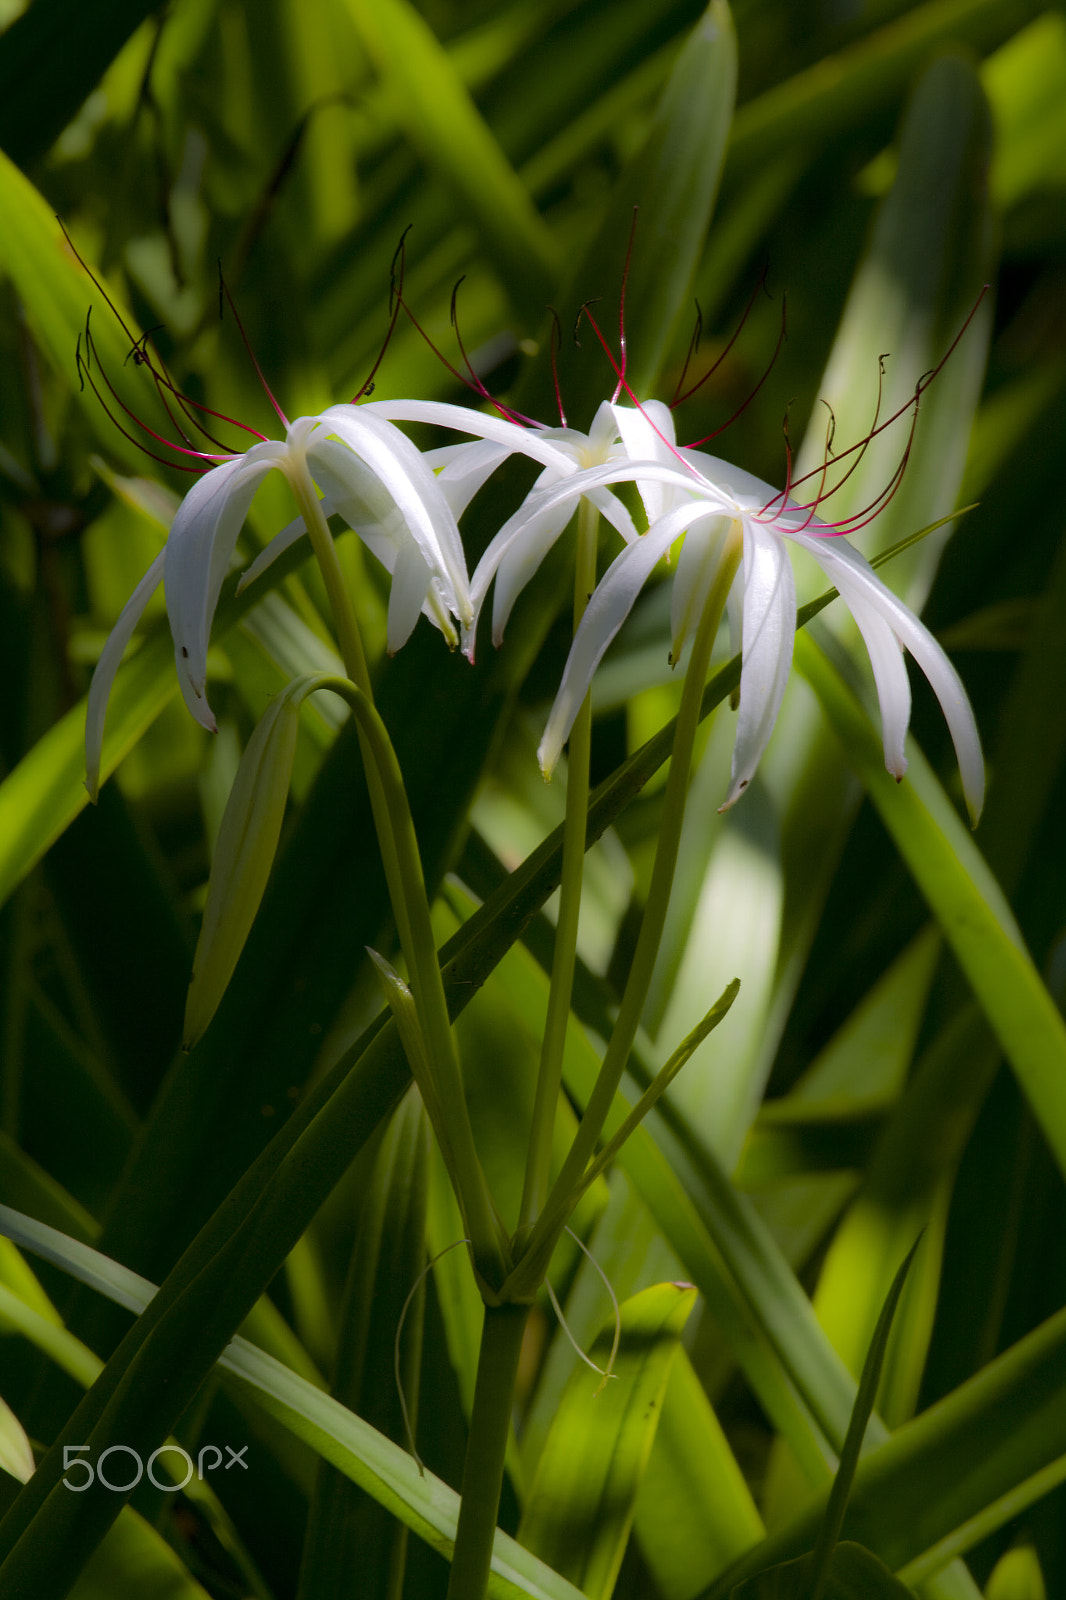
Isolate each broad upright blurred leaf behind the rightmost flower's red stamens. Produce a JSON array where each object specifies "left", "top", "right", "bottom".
[{"left": 795, "top": 56, "right": 992, "bottom": 604}]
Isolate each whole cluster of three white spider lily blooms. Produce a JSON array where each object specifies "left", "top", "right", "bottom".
[{"left": 86, "top": 384, "right": 984, "bottom": 818}]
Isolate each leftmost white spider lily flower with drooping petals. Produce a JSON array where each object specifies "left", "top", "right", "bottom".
[{"left": 85, "top": 405, "right": 474, "bottom": 798}]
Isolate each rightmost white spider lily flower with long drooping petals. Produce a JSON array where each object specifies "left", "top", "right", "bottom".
[{"left": 538, "top": 450, "right": 984, "bottom": 821}]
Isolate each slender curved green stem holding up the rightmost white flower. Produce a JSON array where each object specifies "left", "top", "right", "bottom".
[{"left": 503, "top": 523, "right": 743, "bottom": 1299}]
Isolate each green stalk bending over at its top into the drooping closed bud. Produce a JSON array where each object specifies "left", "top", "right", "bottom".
[{"left": 320, "top": 678, "right": 509, "bottom": 1291}]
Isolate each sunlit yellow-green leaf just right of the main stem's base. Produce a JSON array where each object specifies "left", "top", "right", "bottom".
[{"left": 519, "top": 1283, "right": 696, "bottom": 1600}]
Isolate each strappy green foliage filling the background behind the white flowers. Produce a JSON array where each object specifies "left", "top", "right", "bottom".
[{"left": 0, "top": 0, "right": 1066, "bottom": 1600}]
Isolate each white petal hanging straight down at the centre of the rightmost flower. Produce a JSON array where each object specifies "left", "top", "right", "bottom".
[{"left": 719, "top": 517, "right": 795, "bottom": 811}]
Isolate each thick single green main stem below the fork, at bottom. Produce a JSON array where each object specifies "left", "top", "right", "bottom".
[{"left": 448, "top": 1306, "right": 528, "bottom": 1600}]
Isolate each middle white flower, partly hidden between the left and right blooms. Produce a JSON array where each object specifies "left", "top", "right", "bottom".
[{"left": 360, "top": 400, "right": 677, "bottom": 658}]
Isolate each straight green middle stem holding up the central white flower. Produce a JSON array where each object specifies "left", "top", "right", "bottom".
[{"left": 519, "top": 499, "right": 600, "bottom": 1232}]
